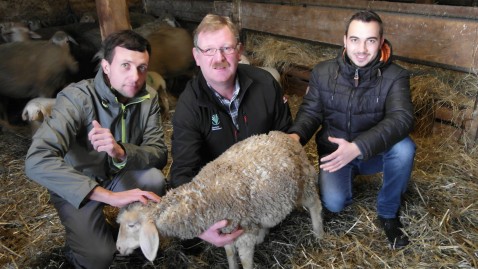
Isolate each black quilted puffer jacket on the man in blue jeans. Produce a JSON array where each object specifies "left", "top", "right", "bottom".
[{"left": 289, "top": 41, "right": 414, "bottom": 159}]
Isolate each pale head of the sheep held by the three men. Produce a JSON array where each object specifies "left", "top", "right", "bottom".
[{"left": 116, "top": 202, "right": 159, "bottom": 261}]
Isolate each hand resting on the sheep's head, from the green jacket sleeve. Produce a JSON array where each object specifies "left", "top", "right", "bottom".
[{"left": 89, "top": 186, "right": 161, "bottom": 207}]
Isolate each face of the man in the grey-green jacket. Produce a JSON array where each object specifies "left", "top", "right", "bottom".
[{"left": 101, "top": 47, "right": 149, "bottom": 102}]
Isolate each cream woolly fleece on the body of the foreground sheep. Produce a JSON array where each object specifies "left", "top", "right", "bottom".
[{"left": 153, "top": 131, "right": 316, "bottom": 239}]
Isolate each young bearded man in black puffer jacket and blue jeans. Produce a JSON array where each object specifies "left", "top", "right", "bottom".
[{"left": 289, "top": 11, "right": 416, "bottom": 248}]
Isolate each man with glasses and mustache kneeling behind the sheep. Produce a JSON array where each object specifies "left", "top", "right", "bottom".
[{"left": 169, "top": 14, "right": 292, "bottom": 246}]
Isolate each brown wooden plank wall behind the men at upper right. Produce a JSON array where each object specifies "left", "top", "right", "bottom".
[{"left": 145, "top": 0, "right": 478, "bottom": 74}]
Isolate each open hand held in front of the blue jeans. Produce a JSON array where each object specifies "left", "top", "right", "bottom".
[{"left": 320, "top": 137, "right": 361, "bottom": 172}]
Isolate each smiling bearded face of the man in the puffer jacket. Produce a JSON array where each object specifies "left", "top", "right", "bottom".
[{"left": 344, "top": 20, "right": 384, "bottom": 67}]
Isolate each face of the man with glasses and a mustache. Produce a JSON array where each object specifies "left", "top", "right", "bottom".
[{"left": 193, "top": 26, "right": 242, "bottom": 88}]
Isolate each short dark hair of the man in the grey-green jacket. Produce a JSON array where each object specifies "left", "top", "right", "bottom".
[{"left": 102, "top": 30, "right": 151, "bottom": 63}]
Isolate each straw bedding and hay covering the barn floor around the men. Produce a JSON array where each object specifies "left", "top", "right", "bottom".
[{"left": 0, "top": 37, "right": 478, "bottom": 269}]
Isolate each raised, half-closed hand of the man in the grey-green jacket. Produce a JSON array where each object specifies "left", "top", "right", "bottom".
[{"left": 88, "top": 120, "right": 126, "bottom": 162}]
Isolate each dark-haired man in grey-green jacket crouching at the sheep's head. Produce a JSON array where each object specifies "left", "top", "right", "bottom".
[{"left": 25, "top": 30, "right": 167, "bottom": 268}]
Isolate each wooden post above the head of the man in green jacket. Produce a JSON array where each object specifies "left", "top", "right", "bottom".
[{"left": 96, "top": 0, "right": 131, "bottom": 40}]
